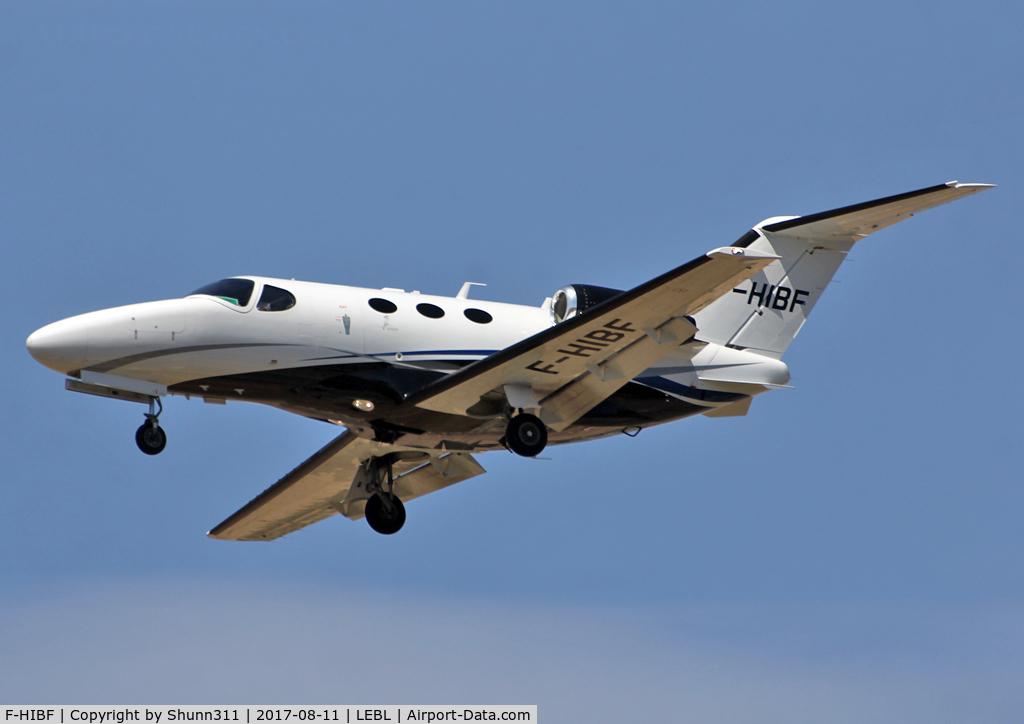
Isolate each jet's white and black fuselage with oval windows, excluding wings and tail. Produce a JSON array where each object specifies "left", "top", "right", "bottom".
[{"left": 28, "top": 276, "right": 788, "bottom": 451}]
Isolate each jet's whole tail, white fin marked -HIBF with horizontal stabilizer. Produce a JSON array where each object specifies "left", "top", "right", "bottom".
[{"left": 694, "top": 181, "right": 992, "bottom": 359}]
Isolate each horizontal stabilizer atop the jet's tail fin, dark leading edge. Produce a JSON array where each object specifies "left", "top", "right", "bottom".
[{"left": 762, "top": 181, "right": 992, "bottom": 251}]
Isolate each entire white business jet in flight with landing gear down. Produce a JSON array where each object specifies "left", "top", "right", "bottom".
[{"left": 28, "top": 181, "right": 991, "bottom": 541}]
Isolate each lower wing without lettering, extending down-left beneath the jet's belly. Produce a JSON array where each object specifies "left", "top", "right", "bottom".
[{"left": 207, "top": 431, "right": 485, "bottom": 541}]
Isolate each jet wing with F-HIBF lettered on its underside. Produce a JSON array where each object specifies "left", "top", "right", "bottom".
[{"left": 409, "top": 247, "right": 778, "bottom": 430}]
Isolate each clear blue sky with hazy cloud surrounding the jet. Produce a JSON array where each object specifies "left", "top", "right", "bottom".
[{"left": 0, "top": 2, "right": 1024, "bottom": 722}]
